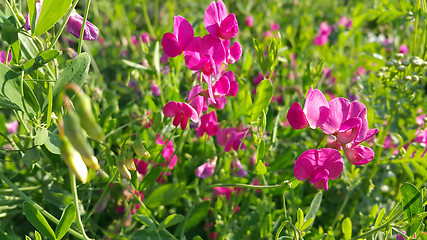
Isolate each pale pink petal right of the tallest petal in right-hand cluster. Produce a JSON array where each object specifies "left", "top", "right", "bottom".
[{"left": 320, "top": 97, "right": 350, "bottom": 135}]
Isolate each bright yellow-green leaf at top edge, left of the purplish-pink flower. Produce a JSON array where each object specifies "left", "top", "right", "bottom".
[{"left": 34, "top": 0, "right": 72, "bottom": 36}]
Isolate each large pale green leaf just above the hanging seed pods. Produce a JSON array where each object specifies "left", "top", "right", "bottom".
[{"left": 43, "top": 53, "right": 90, "bottom": 109}]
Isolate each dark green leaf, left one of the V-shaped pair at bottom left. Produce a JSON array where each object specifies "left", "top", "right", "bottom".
[{"left": 23, "top": 202, "right": 56, "bottom": 239}]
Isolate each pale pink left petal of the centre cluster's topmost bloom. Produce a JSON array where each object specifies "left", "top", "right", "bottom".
[{"left": 203, "top": 0, "right": 227, "bottom": 36}]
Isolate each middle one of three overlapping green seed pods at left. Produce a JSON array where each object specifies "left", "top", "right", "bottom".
[{"left": 64, "top": 110, "right": 99, "bottom": 170}]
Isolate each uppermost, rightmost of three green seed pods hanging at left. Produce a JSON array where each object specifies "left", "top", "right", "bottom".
[{"left": 75, "top": 91, "right": 104, "bottom": 141}]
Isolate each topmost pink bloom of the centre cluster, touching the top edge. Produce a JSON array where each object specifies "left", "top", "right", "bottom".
[{"left": 203, "top": 0, "right": 239, "bottom": 39}]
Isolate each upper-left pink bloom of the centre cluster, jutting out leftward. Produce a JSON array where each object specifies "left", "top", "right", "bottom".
[{"left": 162, "top": 16, "right": 194, "bottom": 58}]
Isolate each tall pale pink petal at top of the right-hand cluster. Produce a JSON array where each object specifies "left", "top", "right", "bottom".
[{"left": 303, "top": 88, "right": 329, "bottom": 129}]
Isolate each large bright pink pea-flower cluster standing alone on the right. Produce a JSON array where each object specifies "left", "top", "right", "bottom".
[{"left": 286, "top": 88, "right": 378, "bottom": 190}]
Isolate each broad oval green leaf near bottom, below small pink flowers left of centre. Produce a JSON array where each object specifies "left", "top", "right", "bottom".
[{"left": 145, "top": 183, "right": 185, "bottom": 208}]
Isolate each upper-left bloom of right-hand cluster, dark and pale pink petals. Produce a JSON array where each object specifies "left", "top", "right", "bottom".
[{"left": 286, "top": 87, "right": 329, "bottom": 129}]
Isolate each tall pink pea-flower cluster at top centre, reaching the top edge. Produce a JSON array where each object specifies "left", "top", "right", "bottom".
[{"left": 162, "top": 0, "right": 242, "bottom": 129}]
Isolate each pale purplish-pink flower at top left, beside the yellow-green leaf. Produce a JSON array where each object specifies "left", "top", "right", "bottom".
[{"left": 67, "top": 10, "right": 99, "bottom": 41}]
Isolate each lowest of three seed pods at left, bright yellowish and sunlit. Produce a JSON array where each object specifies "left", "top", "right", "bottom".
[{"left": 59, "top": 136, "right": 88, "bottom": 184}]
